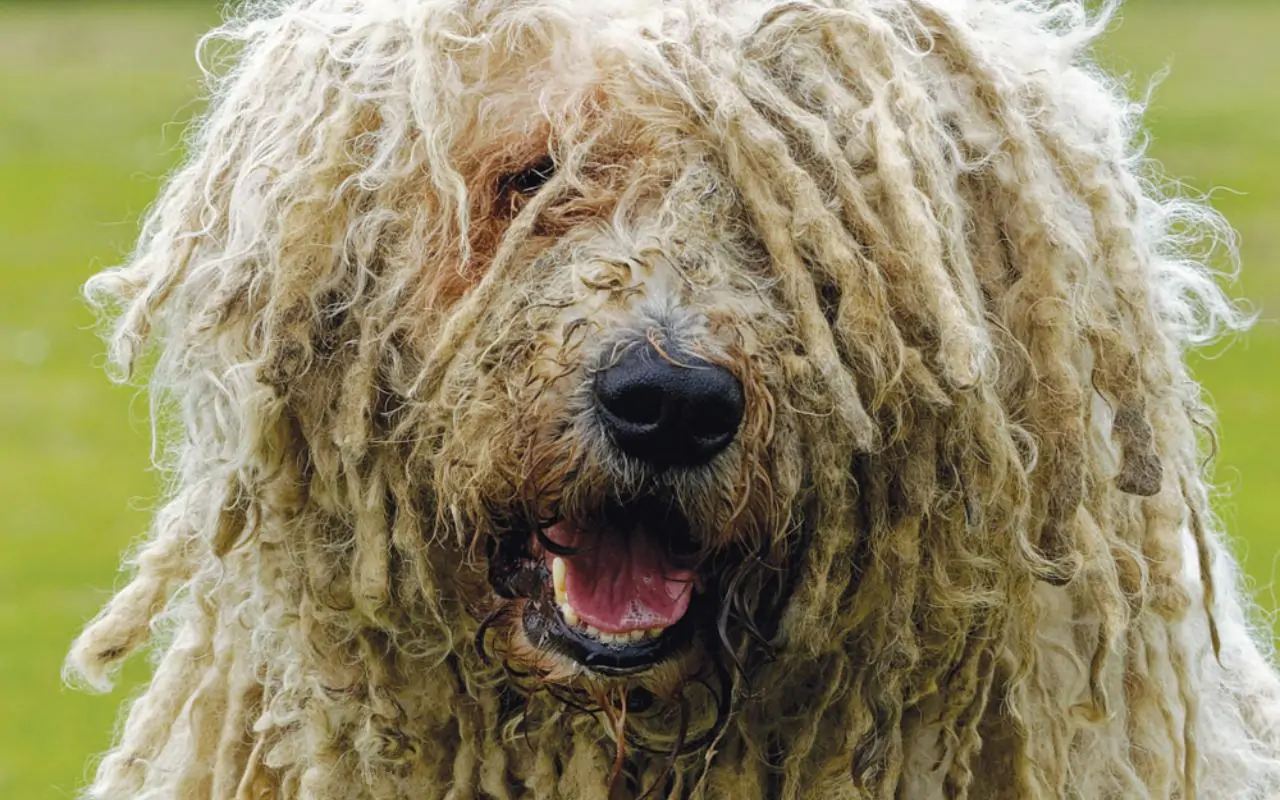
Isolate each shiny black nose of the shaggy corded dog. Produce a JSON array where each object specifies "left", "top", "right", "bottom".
[{"left": 595, "top": 344, "right": 742, "bottom": 467}]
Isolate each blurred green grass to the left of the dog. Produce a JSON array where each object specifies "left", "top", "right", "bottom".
[{"left": 0, "top": 3, "right": 216, "bottom": 800}]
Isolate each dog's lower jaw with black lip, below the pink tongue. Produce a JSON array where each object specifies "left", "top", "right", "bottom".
[{"left": 521, "top": 598, "right": 698, "bottom": 677}]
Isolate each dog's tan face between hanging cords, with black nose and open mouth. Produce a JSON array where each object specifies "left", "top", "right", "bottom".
[{"left": 433, "top": 56, "right": 808, "bottom": 684}]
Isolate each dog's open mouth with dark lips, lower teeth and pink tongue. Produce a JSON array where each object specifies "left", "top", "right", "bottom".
[{"left": 489, "top": 499, "right": 700, "bottom": 675}]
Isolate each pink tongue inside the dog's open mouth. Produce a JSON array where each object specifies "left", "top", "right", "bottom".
[{"left": 545, "top": 522, "right": 694, "bottom": 634}]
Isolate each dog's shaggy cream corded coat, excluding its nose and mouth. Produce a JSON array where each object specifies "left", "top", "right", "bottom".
[{"left": 69, "top": 0, "right": 1280, "bottom": 800}]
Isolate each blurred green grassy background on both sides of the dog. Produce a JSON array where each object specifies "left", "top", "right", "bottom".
[{"left": 0, "top": 0, "right": 1280, "bottom": 800}]
